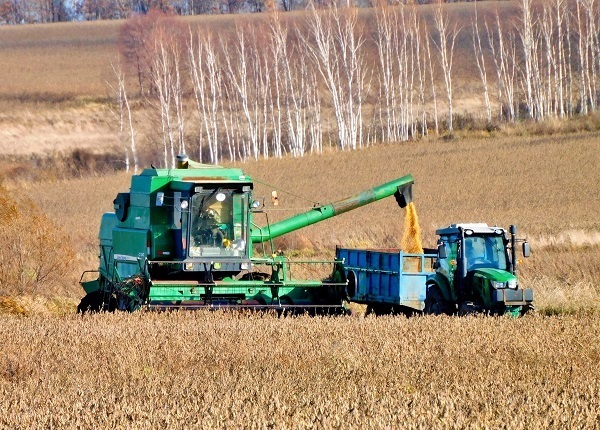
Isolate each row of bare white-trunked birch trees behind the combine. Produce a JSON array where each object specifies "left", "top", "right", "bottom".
[{"left": 114, "top": 0, "right": 600, "bottom": 171}]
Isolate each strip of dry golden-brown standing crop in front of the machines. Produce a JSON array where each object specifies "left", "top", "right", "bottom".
[{"left": 0, "top": 312, "right": 600, "bottom": 428}]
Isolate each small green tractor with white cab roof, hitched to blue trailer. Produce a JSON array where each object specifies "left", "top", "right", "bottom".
[{"left": 424, "top": 224, "right": 533, "bottom": 316}]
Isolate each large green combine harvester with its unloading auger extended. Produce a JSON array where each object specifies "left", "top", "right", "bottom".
[{"left": 78, "top": 155, "right": 413, "bottom": 312}]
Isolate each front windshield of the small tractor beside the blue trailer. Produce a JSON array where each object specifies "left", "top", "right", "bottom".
[{"left": 465, "top": 236, "right": 508, "bottom": 270}]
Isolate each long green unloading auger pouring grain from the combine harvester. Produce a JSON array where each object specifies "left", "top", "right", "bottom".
[{"left": 250, "top": 175, "right": 414, "bottom": 243}]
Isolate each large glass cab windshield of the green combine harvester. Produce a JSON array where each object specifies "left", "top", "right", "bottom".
[{"left": 188, "top": 188, "right": 247, "bottom": 257}]
